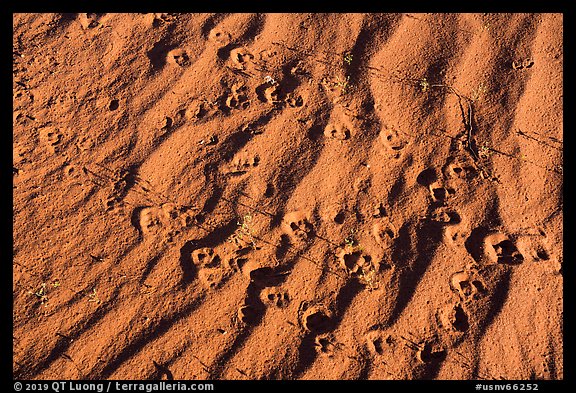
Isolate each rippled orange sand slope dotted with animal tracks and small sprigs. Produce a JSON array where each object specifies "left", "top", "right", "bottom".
[{"left": 12, "top": 14, "right": 564, "bottom": 379}]
